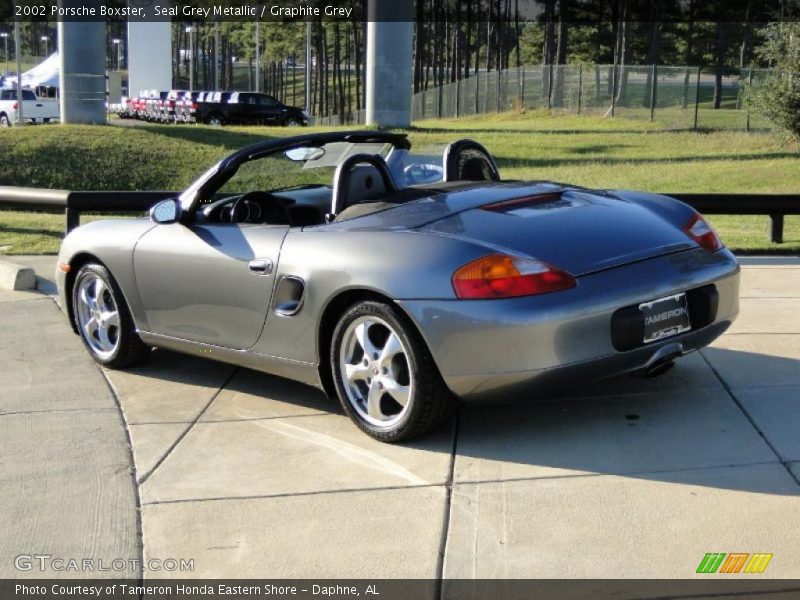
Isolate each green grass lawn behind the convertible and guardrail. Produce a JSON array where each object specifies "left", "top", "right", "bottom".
[{"left": 0, "top": 112, "right": 800, "bottom": 254}]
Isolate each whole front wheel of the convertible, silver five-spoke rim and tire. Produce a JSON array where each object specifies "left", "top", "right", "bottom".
[{"left": 72, "top": 263, "right": 150, "bottom": 369}]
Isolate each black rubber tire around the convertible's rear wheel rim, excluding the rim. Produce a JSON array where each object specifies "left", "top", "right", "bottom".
[{"left": 329, "top": 301, "right": 458, "bottom": 443}]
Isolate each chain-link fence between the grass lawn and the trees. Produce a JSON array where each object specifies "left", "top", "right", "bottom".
[{"left": 412, "top": 65, "right": 769, "bottom": 130}]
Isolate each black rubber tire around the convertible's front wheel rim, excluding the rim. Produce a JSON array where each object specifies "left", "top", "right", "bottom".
[{"left": 71, "top": 263, "right": 151, "bottom": 369}]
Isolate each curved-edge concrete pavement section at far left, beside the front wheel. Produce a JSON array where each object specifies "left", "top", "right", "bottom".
[{"left": 0, "top": 270, "right": 142, "bottom": 578}]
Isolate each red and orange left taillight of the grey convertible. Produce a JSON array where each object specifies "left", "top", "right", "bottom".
[{"left": 453, "top": 254, "right": 577, "bottom": 299}]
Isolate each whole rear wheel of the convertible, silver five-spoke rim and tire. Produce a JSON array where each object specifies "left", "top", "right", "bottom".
[{"left": 331, "top": 301, "right": 456, "bottom": 442}]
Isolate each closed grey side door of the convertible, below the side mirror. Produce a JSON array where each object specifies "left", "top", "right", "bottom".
[{"left": 133, "top": 223, "right": 289, "bottom": 350}]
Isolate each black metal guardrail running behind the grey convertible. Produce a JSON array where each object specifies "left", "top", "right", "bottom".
[{"left": 0, "top": 186, "right": 800, "bottom": 244}]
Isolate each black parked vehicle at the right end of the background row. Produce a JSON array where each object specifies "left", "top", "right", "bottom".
[{"left": 193, "top": 92, "right": 308, "bottom": 126}]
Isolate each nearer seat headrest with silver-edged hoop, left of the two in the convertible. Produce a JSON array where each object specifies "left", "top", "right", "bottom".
[{"left": 331, "top": 154, "right": 397, "bottom": 218}]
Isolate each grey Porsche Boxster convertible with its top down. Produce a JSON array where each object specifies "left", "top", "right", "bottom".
[{"left": 56, "top": 131, "right": 739, "bottom": 442}]
